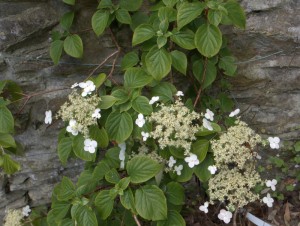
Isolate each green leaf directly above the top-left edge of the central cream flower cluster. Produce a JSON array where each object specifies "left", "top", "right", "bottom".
[{"left": 152, "top": 82, "right": 177, "bottom": 103}]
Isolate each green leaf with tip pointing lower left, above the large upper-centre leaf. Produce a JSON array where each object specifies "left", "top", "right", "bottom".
[{"left": 132, "top": 24, "right": 155, "bottom": 46}]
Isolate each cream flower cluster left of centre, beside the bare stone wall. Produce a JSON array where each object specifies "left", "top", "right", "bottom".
[{"left": 58, "top": 91, "right": 101, "bottom": 138}]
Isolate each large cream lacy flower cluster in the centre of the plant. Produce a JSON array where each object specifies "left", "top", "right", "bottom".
[{"left": 147, "top": 100, "right": 200, "bottom": 155}]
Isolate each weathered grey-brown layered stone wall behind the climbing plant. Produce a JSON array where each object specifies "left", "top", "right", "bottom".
[{"left": 0, "top": 0, "right": 300, "bottom": 220}]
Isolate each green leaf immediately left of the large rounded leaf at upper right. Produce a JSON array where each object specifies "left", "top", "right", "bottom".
[{"left": 171, "top": 29, "right": 196, "bottom": 50}]
